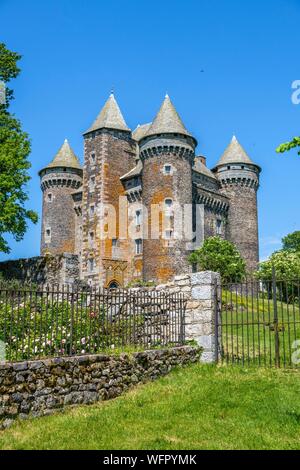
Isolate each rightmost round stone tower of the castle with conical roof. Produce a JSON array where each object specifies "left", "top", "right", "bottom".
[{"left": 213, "top": 136, "right": 261, "bottom": 273}]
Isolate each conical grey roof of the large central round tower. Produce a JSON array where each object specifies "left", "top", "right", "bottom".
[{"left": 145, "top": 95, "right": 192, "bottom": 137}]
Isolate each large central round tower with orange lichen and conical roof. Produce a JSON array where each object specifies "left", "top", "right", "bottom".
[{"left": 140, "top": 95, "right": 197, "bottom": 282}]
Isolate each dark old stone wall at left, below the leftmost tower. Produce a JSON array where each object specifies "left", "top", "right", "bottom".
[{"left": 0, "top": 253, "right": 80, "bottom": 284}]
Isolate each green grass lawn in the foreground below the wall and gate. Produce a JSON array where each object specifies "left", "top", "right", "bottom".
[{"left": 0, "top": 364, "right": 300, "bottom": 450}]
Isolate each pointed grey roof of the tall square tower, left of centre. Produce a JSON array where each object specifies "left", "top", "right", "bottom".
[{"left": 84, "top": 93, "right": 130, "bottom": 134}]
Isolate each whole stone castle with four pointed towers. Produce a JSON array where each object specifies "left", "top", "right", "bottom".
[{"left": 39, "top": 94, "right": 261, "bottom": 287}]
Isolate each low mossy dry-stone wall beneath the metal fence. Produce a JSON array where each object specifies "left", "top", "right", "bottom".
[{"left": 0, "top": 346, "right": 201, "bottom": 428}]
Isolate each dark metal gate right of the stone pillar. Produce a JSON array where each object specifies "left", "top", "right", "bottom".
[{"left": 216, "top": 274, "right": 300, "bottom": 367}]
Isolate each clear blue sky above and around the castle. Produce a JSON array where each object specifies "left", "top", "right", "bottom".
[{"left": 0, "top": 0, "right": 300, "bottom": 260}]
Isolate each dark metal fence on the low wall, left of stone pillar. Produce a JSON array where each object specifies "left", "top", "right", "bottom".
[{"left": 0, "top": 286, "right": 185, "bottom": 361}]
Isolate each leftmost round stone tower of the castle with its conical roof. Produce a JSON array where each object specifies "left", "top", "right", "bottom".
[{"left": 39, "top": 140, "right": 82, "bottom": 255}]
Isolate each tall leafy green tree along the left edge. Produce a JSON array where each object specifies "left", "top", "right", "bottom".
[{"left": 0, "top": 43, "right": 38, "bottom": 253}]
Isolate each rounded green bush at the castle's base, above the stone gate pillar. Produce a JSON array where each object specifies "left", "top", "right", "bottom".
[{"left": 188, "top": 237, "right": 246, "bottom": 282}]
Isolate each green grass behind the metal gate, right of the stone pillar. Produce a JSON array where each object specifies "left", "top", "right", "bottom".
[{"left": 221, "top": 291, "right": 300, "bottom": 367}]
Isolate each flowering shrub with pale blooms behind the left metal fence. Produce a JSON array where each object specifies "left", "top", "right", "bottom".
[{"left": 0, "top": 292, "right": 144, "bottom": 360}]
